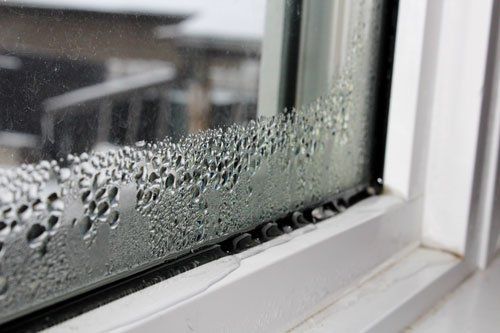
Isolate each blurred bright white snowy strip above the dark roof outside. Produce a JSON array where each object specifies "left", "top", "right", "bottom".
[{"left": 0, "top": 0, "right": 266, "bottom": 40}]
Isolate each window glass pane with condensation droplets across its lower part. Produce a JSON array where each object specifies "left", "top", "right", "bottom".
[{"left": 0, "top": 0, "right": 381, "bottom": 322}]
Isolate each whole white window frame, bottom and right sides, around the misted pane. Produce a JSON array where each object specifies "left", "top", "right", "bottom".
[{"left": 49, "top": 0, "right": 500, "bottom": 332}]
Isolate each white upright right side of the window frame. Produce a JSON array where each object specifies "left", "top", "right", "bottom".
[{"left": 385, "top": 0, "right": 499, "bottom": 265}]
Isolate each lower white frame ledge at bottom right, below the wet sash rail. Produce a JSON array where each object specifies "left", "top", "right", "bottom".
[{"left": 292, "top": 248, "right": 469, "bottom": 333}]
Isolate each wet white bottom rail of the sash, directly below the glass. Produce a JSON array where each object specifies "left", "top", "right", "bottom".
[{"left": 48, "top": 195, "right": 430, "bottom": 332}]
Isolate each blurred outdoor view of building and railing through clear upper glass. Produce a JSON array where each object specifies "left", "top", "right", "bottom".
[{"left": 0, "top": 0, "right": 265, "bottom": 166}]
